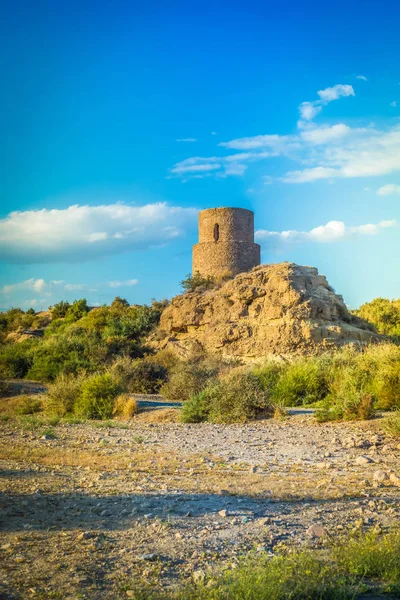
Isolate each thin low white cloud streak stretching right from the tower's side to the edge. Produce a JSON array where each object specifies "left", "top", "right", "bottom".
[{"left": 256, "top": 220, "right": 397, "bottom": 243}]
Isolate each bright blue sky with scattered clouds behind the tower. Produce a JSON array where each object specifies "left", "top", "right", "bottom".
[{"left": 0, "top": 0, "right": 400, "bottom": 309}]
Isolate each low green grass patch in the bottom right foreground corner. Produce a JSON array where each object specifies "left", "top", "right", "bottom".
[{"left": 169, "top": 531, "right": 400, "bottom": 600}]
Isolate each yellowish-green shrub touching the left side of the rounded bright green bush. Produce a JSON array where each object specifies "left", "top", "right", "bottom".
[{"left": 45, "top": 373, "right": 84, "bottom": 417}]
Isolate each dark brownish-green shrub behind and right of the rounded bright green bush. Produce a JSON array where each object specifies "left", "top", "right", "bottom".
[{"left": 110, "top": 357, "right": 168, "bottom": 394}]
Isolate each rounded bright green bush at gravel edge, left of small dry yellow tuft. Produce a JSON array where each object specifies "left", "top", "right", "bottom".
[{"left": 74, "top": 373, "right": 121, "bottom": 419}]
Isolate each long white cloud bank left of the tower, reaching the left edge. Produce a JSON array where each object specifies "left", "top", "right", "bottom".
[{"left": 0, "top": 202, "right": 197, "bottom": 264}]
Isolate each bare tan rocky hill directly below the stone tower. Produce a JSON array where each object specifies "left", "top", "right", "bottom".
[{"left": 152, "top": 263, "right": 382, "bottom": 360}]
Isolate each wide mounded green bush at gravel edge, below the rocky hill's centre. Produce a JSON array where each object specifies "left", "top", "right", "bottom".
[{"left": 181, "top": 370, "right": 273, "bottom": 423}]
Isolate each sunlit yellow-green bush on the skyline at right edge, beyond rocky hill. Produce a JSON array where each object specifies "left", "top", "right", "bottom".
[{"left": 354, "top": 298, "right": 400, "bottom": 341}]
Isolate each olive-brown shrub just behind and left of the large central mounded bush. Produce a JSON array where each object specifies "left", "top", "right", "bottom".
[{"left": 160, "top": 362, "right": 218, "bottom": 401}]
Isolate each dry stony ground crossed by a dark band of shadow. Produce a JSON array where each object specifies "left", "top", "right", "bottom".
[{"left": 0, "top": 411, "right": 400, "bottom": 599}]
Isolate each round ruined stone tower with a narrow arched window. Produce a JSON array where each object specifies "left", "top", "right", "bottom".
[{"left": 192, "top": 208, "right": 260, "bottom": 277}]
